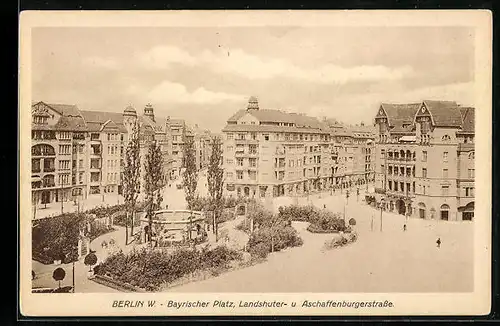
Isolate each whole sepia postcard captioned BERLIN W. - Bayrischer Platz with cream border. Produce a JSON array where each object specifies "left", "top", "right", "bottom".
[{"left": 19, "top": 10, "right": 492, "bottom": 317}]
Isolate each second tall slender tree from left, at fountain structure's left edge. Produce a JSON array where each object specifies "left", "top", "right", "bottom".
[{"left": 144, "top": 142, "right": 163, "bottom": 241}]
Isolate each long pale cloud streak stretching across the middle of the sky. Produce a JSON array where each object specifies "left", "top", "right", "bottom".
[{"left": 137, "top": 46, "right": 414, "bottom": 84}]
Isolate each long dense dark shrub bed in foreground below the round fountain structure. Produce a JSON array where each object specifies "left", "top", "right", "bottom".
[{"left": 96, "top": 247, "right": 241, "bottom": 291}]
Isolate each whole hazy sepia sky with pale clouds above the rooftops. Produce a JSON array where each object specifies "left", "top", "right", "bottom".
[{"left": 32, "top": 26, "right": 474, "bottom": 131}]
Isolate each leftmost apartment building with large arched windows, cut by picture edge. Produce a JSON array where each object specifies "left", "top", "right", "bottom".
[{"left": 31, "top": 102, "right": 89, "bottom": 205}]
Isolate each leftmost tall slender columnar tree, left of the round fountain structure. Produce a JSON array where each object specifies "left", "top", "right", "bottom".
[{"left": 123, "top": 122, "right": 141, "bottom": 244}]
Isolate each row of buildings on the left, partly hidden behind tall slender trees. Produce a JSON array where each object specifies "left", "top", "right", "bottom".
[{"left": 31, "top": 102, "right": 210, "bottom": 205}]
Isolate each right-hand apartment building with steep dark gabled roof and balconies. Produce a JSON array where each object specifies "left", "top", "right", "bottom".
[{"left": 375, "top": 101, "right": 475, "bottom": 220}]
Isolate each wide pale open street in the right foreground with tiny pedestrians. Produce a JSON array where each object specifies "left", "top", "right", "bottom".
[{"left": 169, "top": 188, "right": 473, "bottom": 292}]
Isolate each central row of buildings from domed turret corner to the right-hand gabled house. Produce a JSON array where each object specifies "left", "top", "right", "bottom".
[{"left": 222, "top": 97, "right": 375, "bottom": 198}]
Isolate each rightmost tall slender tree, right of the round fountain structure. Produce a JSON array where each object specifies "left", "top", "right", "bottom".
[{"left": 207, "top": 136, "right": 224, "bottom": 241}]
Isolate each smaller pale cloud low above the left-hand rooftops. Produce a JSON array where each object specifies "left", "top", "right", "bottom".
[{"left": 128, "top": 81, "right": 245, "bottom": 105}]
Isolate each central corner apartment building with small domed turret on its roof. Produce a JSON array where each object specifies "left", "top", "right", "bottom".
[{"left": 222, "top": 97, "right": 336, "bottom": 197}]
